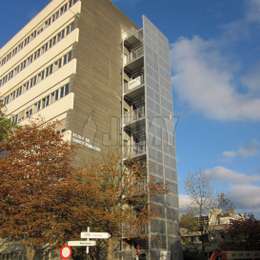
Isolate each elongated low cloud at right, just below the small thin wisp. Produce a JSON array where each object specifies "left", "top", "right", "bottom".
[{"left": 205, "top": 166, "right": 260, "bottom": 186}]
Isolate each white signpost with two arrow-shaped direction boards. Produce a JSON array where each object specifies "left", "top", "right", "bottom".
[{"left": 68, "top": 227, "right": 111, "bottom": 254}]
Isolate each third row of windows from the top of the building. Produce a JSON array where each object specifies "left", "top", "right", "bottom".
[{"left": 4, "top": 50, "right": 73, "bottom": 105}]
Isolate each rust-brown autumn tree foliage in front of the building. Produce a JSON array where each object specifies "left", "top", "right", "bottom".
[{"left": 0, "top": 121, "right": 165, "bottom": 259}]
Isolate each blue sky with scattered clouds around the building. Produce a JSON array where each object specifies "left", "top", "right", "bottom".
[{"left": 0, "top": 0, "right": 260, "bottom": 218}]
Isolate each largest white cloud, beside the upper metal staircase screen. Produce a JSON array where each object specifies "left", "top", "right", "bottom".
[{"left": 172, "top": 36, "right": 260, "bottom": 120}]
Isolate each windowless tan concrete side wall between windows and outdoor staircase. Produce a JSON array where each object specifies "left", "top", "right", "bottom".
[{"left": 67, "top": 0, "right": 135, "bottom": 164}]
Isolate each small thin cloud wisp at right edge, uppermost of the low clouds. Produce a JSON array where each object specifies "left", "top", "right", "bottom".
[{"left": 222, "top": 142, "right": 260, "bottom": 158}]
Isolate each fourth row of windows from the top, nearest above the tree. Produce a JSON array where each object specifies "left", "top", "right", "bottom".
[{"left": 11, "top": 84, "right": 70, "bottom": 124}]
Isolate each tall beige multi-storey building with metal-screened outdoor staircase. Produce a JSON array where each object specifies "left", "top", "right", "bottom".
[{"left": 0, "top": 0, "right": 179, "bottom": 260}]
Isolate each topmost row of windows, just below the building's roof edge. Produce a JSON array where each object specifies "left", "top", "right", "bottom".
[{"left": 0, "top": 0, "right": 78, "bottom": 66}]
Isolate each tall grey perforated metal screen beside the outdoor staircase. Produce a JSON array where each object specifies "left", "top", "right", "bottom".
[{"left": 143, "top": 17, "right": 179, "bottom": 259}]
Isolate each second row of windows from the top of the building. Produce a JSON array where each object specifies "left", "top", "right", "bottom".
[{"left": 0, "top": 21, "right": 75, "bottom": 87}]
